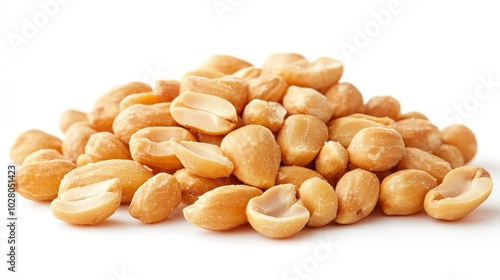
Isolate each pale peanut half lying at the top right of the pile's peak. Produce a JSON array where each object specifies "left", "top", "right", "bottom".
[{"left": 272, "top": 57, "right": 344, "bottom": 91}]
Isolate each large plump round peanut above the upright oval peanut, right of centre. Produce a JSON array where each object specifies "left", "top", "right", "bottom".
[{"left": 347, "top": 127, "right": 405, "bottom": 171}]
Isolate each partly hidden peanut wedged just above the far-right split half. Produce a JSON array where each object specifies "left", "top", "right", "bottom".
[{"left": 397, "top": 147, "right": 451, "bottom": 184}]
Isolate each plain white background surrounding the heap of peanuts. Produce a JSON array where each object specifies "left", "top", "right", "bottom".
[{"left": 0, "top": 0, "right": 500, "bottom": 280}]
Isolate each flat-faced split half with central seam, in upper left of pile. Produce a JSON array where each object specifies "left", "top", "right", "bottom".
[{"left": 170, "top": 91, "right": 238, "bottom": 135}]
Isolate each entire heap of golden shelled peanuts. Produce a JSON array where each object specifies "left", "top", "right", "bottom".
[{"left": 10, "top": 53, "right": 493, "bottom": 238}]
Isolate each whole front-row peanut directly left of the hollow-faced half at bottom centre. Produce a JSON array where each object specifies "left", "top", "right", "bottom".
[{"left": 183, "top": 185, "right": 262, "bottom": 231}]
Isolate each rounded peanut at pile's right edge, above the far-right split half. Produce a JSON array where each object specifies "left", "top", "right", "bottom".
[{"left": 441, "top": 124, "right": 477, "bottom": 163}]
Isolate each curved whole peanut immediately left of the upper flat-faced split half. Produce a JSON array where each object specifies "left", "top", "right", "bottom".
[{"left": 113, "top": 102, "right": 177, "bottom": 144}]
